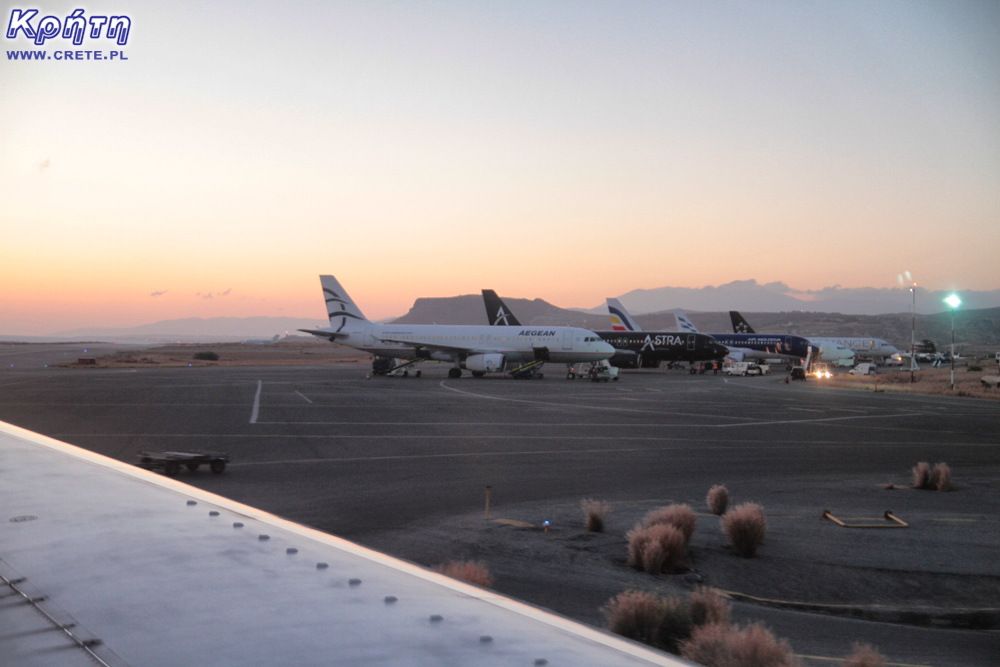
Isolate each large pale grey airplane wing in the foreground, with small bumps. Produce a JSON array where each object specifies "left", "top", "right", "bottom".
[{"left": 0, "top": 422, "right": 688, "bottom": 667}]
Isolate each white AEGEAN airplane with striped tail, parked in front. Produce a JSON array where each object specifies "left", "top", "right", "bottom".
[{"left": 299, "top": 276, "right": 615, "bottom": 378}]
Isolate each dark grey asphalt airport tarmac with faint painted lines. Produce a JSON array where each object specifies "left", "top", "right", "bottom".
[{"left": 0, "top": 345, "right": 1000, "bottom": 665}]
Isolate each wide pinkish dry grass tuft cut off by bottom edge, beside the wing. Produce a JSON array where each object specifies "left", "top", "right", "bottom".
[{"left": 681, "top": 623, "right": 800, "bottom": 667}]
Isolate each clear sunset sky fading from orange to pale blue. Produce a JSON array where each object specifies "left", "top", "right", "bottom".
[{"left": 0, "top": 0, "right": 1000, "bottom": 335}]
